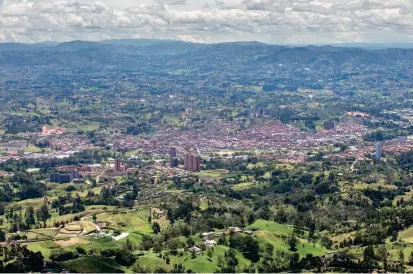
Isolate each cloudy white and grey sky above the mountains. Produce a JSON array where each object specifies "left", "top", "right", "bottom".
[{"left": 0, "top": 0, "right": 413, "bottom": 44}]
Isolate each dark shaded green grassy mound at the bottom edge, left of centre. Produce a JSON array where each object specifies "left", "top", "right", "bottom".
[{"left": 62, "top": 257, "right": 121, "bottom": 273}]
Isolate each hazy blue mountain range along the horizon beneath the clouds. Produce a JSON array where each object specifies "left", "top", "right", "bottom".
[{"left": 0, "top": 39, "right": 413, "bottom": 83}]
